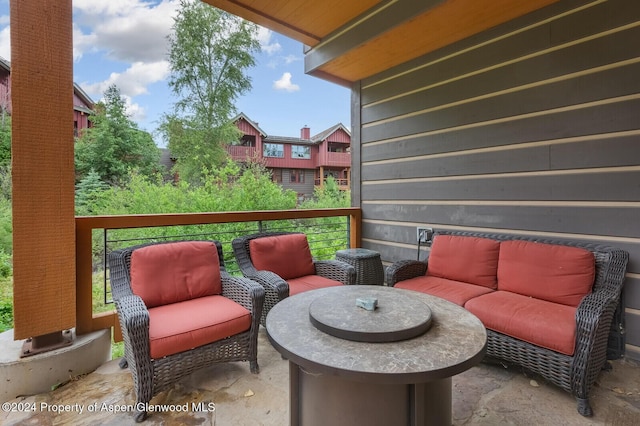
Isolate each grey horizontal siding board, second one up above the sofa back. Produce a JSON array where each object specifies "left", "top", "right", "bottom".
[{"left": 362, "top": 168, "right": 640, "bottom": 202}]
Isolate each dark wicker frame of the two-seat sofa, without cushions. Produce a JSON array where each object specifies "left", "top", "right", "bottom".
[{"left": 386, "top": 231, "right": 629, "bottom": 416}]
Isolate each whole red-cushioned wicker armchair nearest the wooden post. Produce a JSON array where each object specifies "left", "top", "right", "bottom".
[{"left": 109, "top": 241, "right": 264, "bottom": 422}]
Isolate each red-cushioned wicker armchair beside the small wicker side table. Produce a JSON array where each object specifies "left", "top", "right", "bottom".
[{"left": 232, "top": 232, "right": 356, "bottom": 325}]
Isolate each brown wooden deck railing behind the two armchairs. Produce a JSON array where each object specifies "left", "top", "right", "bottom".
[{"left": 76, "top": 208, "right": 362, "bottom": 340}]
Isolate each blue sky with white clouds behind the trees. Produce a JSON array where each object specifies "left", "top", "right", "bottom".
[{"left": 0, "top": 0, "right": 351, "bottom": 145}]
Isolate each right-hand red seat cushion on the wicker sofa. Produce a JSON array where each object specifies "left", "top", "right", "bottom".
[{"left": 464, "top": 291, "right": 577, "bottom": 355}]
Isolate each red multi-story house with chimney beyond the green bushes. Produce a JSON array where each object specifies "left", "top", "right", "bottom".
[{"left": 227, "top": 113, "right": 351, "bottom": 199}]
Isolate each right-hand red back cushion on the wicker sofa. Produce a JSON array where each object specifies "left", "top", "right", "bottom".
[{"left": 498, "top": 240, "right": 595, "bottom": 306}]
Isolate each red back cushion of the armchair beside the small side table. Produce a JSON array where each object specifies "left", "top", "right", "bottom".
[{"left": 249, "top": 234, "right": 316, "bottom": 280}]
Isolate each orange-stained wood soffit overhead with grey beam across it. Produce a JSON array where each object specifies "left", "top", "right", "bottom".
[{"left": 204, "top": 0, "right": 558, "bottom": 86}]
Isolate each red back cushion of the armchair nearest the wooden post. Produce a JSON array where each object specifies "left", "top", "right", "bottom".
[{"left": 131, "top": 241, "right": 222, "bottom": 308}]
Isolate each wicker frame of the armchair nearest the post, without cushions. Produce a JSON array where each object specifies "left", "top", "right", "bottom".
[{"left": 109, "top": 241, "right": 265, "bottom": 419}]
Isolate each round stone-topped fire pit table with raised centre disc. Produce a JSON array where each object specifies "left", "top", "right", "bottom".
[{"left": 266, "top": 285, "right": 487, "bottom": 426}]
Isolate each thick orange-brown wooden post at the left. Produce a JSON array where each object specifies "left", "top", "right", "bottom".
[{"left": 10, "top": 0, "right": 76, "bottom": 340}]
